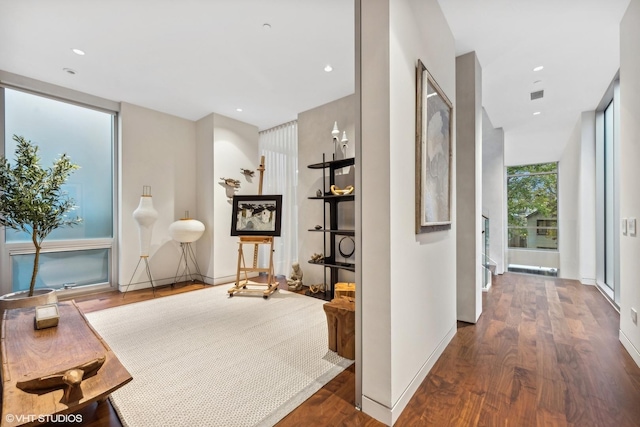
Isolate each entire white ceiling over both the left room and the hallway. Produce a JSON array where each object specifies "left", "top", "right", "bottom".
[{"left": 0, "top": 0, "right": 629, "bottom": 152}]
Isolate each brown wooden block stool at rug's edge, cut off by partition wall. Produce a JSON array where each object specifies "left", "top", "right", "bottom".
[{"left": 323, "top": 297, "right": 356, "bottom": 360}]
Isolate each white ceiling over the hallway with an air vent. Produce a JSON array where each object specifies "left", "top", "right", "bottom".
[{"left": 439, "top": 0, "right": 635, "bottom": 161}]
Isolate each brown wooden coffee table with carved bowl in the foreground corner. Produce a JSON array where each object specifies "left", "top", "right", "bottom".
[{"left": 0, "top": 301, "right": 132, "bottom": 426}]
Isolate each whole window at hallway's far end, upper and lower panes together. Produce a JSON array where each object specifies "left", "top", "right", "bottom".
[{"left": 507, "top": 163, "right": 559, "bottom": 276}]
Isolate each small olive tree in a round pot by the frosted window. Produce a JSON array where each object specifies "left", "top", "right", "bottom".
[{"left": 0, "top": 135, "right": 82, "bottom": 313}]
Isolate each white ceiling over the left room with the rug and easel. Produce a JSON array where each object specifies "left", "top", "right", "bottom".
[{"left": 0, "top": 0, "right": 355, "bottom": 129}]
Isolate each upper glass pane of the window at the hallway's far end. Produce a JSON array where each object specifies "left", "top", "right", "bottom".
[{"left": 507, "top": 163, "right": 558, "bottom": 250}]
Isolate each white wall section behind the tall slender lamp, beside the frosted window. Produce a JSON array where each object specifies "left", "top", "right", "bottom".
[{"left": 118, "top": 103, "right": 196, "bottom": 290}]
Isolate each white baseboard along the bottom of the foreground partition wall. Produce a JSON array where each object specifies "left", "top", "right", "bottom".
[{"left": 362, "top": 324, "right": 457, "bottom": 426}]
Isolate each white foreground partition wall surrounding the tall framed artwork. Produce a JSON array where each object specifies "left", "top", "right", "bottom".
[{"left": 360, "top": 0, "right": 456, "bottom": 424}]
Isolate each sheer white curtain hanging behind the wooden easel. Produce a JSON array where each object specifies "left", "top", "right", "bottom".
[{"left": 259, "top": 121, "right": 298, "bottom": 275}]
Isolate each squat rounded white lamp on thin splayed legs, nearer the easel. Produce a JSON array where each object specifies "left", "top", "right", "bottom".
[{"left": 169, "top": 211, "right": 205, "bottom": 285}]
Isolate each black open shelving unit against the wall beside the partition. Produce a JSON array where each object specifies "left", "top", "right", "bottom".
[{"left": 307, "top": 155, "right": 356, "bottom": 301}]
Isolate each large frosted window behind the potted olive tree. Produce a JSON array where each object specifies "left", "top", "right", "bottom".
[{"left": 0, "top": 88, "right": 116, "bottom": 293}]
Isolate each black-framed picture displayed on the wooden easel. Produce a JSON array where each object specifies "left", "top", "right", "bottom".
[{"left": 231, "top": 194, "right": 282, "bottom": 236}]
